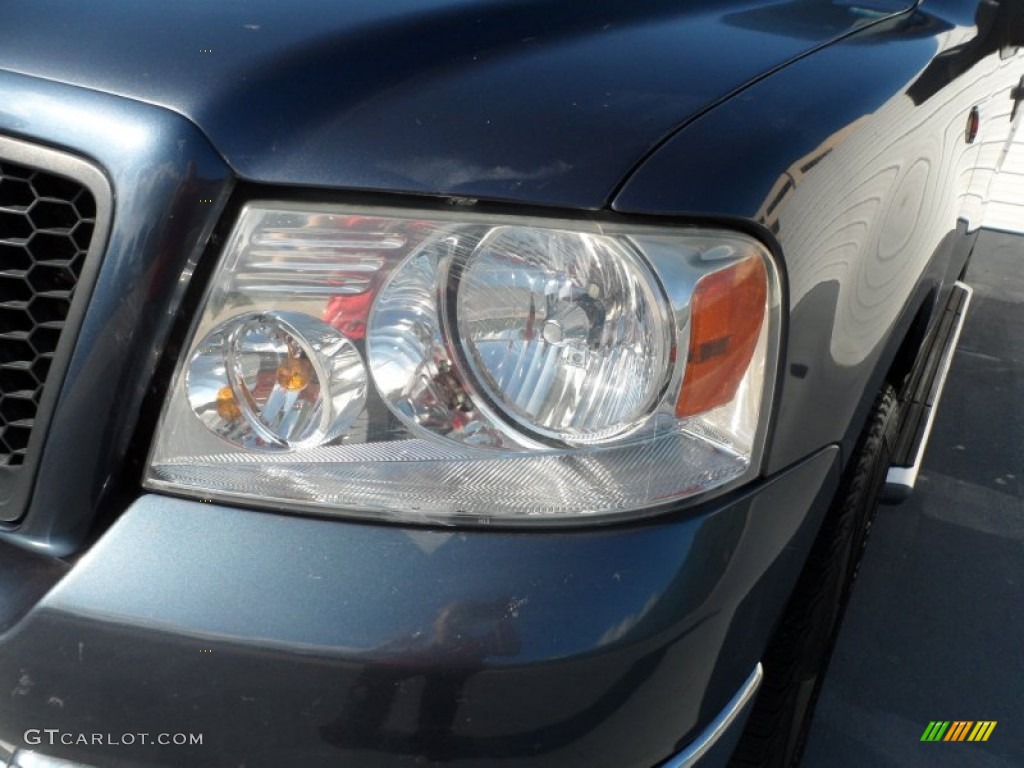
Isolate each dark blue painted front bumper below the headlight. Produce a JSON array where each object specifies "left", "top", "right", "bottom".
[{"left": 0, "top": 449, "right": 838, "bottom": 768}]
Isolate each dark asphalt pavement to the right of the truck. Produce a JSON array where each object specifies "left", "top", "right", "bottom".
[{"left": 803, "top": 231, "right": 1024, "bottom": 768}]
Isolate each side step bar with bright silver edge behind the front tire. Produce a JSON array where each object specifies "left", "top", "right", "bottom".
[{"left": 883, "top": 281, "right": 974, "bottom": 502}]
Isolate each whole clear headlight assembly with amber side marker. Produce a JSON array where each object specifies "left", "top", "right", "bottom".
[{"left": 146, "top": 205, "right": 779, "bottom": 521}]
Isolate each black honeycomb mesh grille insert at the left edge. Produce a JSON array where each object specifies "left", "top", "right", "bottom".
[{"left": 0, "top": 161, "right": 96, "bottom": 467}]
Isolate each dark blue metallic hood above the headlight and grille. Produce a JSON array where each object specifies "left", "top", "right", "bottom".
[{"left": 0, "top": 0, "right": 902, "bottom": 208}]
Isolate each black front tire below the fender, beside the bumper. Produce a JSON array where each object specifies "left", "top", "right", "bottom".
[{"left": 730, "top": 384, "right": 900, "bottom": 768}]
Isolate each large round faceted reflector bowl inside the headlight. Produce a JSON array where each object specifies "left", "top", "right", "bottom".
[{"left": 455, "top": 226, "right": 673, "bottom": 443}]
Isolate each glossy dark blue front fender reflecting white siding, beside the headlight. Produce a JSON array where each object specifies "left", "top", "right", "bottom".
[{"left": 613, "top": 0, "right": 1021, "bottom": 474}]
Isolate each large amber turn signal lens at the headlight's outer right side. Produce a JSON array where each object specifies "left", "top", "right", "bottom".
[{"left": 676, "top": 254, "right": 768, "bottom": 418}]
